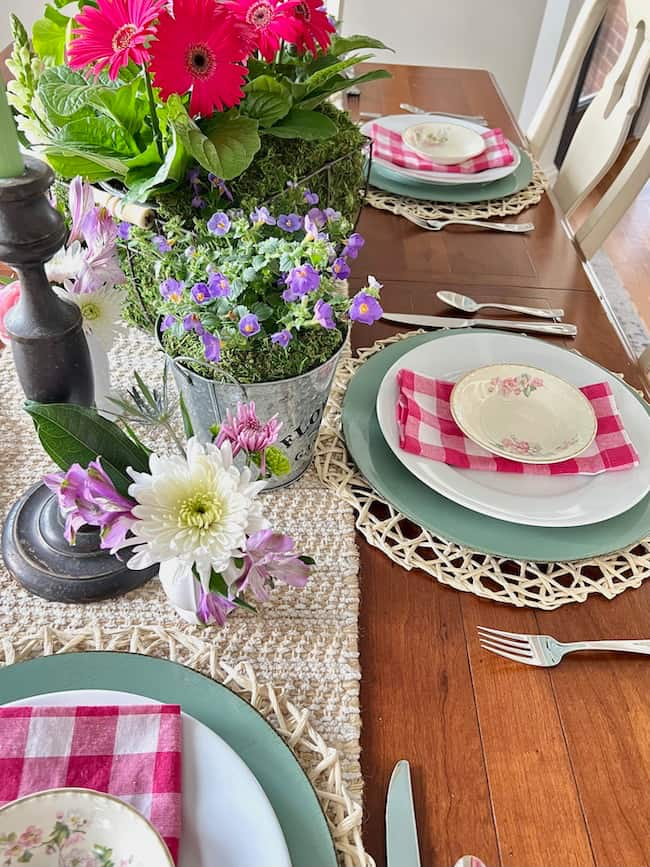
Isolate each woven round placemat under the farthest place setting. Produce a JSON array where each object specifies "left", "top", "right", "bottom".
[{"left": 366, "top": 154, "right": 548, "bottom": 220}]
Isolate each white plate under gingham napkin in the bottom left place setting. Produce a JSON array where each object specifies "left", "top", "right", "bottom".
[{"left": 8, "top": 689, "right": 291, "bottom": 867}]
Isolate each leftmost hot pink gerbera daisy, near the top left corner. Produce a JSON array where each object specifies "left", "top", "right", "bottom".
[{"left": 68, "top": 0, "right": 167, "bottom": 81}]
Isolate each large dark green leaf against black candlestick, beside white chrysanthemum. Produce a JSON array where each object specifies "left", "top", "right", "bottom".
[{"left": 25, "top": 401, "right": 149, "bottom": 495}]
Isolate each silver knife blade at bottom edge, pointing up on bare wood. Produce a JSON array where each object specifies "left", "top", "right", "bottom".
[{"left": 386, "top": 759, "right": 420, "bottom": 867}]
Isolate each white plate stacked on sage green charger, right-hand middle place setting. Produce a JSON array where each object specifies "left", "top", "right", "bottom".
[{"left": 343, "top": 329, "right": 650, "bottom": 561}]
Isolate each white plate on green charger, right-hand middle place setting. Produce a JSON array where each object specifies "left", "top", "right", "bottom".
[{"left": 376, "top": 332, "right": 650, "bottom": 527}]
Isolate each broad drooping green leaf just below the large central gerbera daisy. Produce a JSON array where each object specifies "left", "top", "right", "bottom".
[{"left": 167, "top": 94, "right": 261, "bottom": 180}]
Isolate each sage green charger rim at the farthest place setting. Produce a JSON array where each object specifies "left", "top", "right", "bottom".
[{"left": 370, "top": 150, "right": 533, "bottom": 204}]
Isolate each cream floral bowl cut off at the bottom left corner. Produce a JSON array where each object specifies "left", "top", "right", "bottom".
[{"left": 0, "top": 789, "right": 174, "bottom": 867}]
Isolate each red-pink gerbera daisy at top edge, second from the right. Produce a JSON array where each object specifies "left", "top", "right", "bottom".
[{"left": 224, "top": 0, "right": 300, "bottom": 63}]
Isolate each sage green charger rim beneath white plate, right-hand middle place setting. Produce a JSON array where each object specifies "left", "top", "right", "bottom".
[{"left": 342, "top": 329, "right": 650, "bottom": 562}]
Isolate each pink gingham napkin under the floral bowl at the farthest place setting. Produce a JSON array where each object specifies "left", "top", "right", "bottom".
[{"left": 370, "top": 123, "right": 515, "bottom": 175}]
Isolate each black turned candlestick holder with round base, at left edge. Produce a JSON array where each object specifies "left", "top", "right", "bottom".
[{"left": 0, "top": 157, "right": 157, "bottom": 602}]
